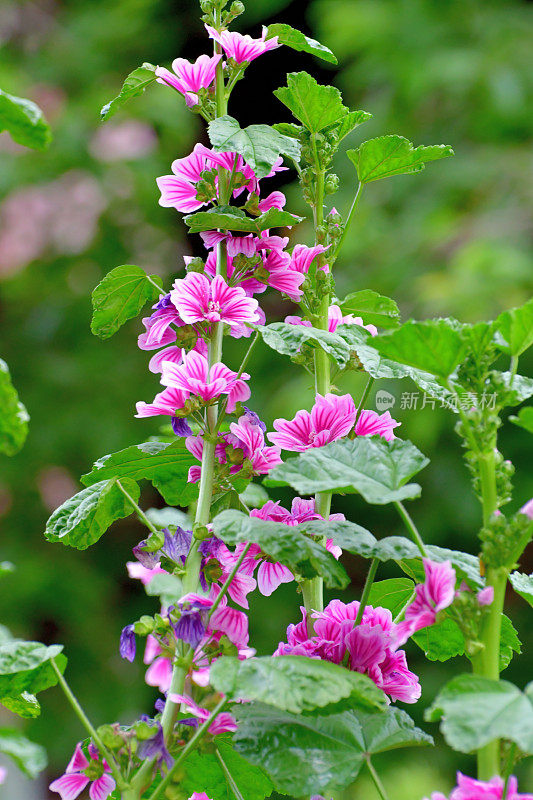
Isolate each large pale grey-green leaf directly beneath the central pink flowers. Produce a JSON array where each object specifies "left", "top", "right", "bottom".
[{"left": 264, "top": 436, "right": 429, "bottom": 505}]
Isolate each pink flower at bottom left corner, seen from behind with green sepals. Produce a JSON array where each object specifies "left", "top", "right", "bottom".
[{"left": 50, "top": 742, "right": 116, "bottom": 800}]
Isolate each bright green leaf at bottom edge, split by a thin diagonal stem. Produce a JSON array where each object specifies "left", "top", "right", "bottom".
[{"left": 180, "top": 735, "right": 274, "bottom": 800}]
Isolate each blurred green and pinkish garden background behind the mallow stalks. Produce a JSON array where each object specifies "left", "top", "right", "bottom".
[{"left": 0, "top": 0, "right": 533, "bottom": 800}]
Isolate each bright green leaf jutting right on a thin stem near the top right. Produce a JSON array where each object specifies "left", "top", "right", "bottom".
[{"left": 346, "top": 135, "right": 454, "bottom": 183}]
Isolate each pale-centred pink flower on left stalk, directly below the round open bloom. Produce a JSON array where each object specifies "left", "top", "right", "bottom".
[{"left": 161, "top": 350, "right": 250, "bottom": 413}]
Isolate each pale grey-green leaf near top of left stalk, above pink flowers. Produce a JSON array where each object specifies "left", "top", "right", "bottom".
[{"left": 208, "top": 114, "right": 301, "bottom": 178}]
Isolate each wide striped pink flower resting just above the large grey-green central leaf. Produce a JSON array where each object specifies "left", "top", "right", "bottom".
[{"left": 267, "top": 394, "right": 356, "bottom": 453}]
